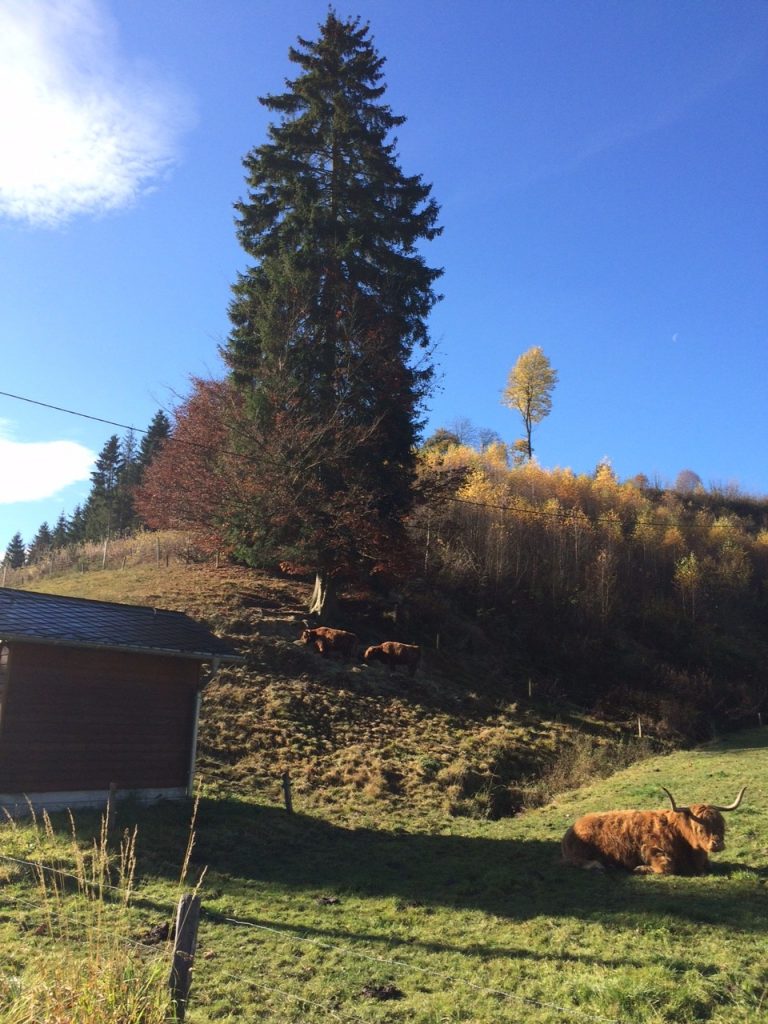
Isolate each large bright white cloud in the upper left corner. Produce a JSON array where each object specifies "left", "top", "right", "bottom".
[{"left": 0, "top": 0, "right": 189, "bottom": 226}]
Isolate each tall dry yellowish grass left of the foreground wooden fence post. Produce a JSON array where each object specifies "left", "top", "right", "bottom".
[{"left": 0, "top": 813, "right": 173, "bottom": 1024}]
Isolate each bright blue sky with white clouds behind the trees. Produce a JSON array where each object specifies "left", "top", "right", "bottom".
[{"left": 0, "top": 0, "right": 768, "bottom": 548}]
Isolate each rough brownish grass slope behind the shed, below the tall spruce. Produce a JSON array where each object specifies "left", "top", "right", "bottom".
[{"left": 15, "top": 562, "right": 658, "bottom": 817}]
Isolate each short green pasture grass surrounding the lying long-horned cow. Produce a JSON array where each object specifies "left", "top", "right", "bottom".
[{"left": 0, "top": 731, "right": 768, "bottom": 1024}]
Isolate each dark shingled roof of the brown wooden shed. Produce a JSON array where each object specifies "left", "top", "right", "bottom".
[{"left": 0, "top": 587, "right": 241, "bottom": 660}]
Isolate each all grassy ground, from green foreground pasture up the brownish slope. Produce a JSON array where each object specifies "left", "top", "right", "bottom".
[{"left": 0, "top": 564, "right": 768, "bottom": 1024}]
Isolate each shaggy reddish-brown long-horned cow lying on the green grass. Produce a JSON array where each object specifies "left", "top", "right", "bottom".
[{"left": 562, "top": 786, "right": 746, "bottom": 874}]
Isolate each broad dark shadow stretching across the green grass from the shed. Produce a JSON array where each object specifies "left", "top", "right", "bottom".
[{"left": 83, "top": 800, "right": 768, "bottom": 934}]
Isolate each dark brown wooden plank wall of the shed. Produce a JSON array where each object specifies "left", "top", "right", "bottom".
[{"left": 0, "top": 643, "right": 200, "bottom": 793}]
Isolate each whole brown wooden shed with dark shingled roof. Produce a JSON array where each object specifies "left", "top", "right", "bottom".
[{"left": 0, "top": 587, "right": 242, "bottom": 814}]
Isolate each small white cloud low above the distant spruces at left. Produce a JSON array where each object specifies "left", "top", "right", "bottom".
[{"left": 0, "top": 437, "right": 96, "bottom": 505}]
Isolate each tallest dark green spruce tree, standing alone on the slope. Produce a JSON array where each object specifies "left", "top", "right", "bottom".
[{"left": 223, "top": 11, "right": 442, "bottom": 613}]
